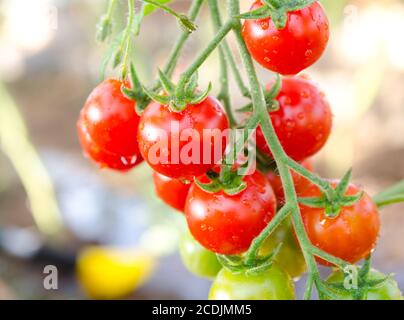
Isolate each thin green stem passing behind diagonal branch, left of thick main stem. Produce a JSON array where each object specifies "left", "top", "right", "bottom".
[{"left": 209, "top": 0, "right": 237, "bottom": 128}]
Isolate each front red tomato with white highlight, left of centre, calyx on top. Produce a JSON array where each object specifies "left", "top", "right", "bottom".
[{"left": 138, "top": 97, "right": 229, "bottom": 180}]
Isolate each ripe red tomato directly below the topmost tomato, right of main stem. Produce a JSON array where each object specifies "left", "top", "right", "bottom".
[{"left": 256, "top": 77, "right": 332, "bottom": 161}]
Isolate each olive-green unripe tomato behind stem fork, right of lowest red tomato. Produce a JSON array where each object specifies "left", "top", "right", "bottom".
[{"left": 260, "top": 220, "right": 306, "bottom": 278}]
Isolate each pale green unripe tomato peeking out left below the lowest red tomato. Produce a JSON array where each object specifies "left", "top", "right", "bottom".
[{"left": 180, "top": 232, "right": 222, "bottom": 279}]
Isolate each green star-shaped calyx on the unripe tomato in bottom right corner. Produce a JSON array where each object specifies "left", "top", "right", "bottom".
[{"left": 323, "top": 256, "right": 392, "bottom": 300}]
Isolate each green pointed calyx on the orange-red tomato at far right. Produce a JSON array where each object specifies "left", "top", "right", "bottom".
[{"left": 298, "top": 170, "right": 364, "bottom": 219}]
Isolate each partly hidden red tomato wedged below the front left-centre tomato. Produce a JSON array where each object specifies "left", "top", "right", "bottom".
[{"left": 153, "top": 172, "right": 191, "bottom": 212}]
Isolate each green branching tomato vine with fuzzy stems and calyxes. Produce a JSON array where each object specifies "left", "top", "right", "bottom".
[{"left": 80, "top": 0, "right": 404, "bottom": 299}]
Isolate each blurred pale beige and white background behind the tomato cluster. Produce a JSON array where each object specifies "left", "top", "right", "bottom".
[{"left": 0, "top": 0, "right": 404, "bottom": 299}]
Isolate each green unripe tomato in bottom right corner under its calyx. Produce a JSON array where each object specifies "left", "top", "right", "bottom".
[{"left": 327, "top": 269, "right": 403, "bottom": 300}]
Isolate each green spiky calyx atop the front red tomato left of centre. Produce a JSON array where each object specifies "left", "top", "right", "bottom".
[{"left": 143, "top": 70, "right": 212, "bottom": 112}]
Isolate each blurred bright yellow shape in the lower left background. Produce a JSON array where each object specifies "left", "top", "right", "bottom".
[{"left": 77, "top": 247, "right": 156, "bottom": 300}]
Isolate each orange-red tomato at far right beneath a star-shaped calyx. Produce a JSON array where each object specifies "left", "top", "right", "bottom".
[{"left": 300, "top": 182, "right": 380, "bottom": 265}]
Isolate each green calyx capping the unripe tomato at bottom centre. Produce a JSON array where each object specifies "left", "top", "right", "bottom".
[{"left": 217, "top": 243, "right": 283, "bottom": 276}]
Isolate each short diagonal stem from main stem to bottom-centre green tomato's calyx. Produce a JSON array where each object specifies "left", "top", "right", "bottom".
[{"left": 246, "top": 205, "right": 291, "bottom": 265}]
